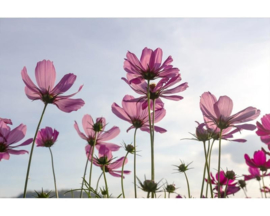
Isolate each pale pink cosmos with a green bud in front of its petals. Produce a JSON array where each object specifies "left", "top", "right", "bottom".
[{"left": 74, "top": 114, "right": 120, "bottom": 152}]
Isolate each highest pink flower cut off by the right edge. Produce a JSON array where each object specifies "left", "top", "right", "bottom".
[{"left": 256, "top": 114, "right": 270, "bottom": 146}]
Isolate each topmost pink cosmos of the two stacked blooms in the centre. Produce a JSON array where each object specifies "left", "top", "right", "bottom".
[{"left": 124, "top": 47, "right": 179, "bottom": 83}]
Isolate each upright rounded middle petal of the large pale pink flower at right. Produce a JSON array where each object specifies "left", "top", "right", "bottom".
[{"left": 214, "top": 96, "right": 233, "bottom": 118}]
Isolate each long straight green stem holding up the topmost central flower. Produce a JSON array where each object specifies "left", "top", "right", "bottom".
[{"left": 147, "top": 80, "right": 155, "bottom": 198}]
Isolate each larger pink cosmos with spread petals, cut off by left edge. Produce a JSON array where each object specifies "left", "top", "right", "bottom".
[{"left": 0, "top": 120, "right": 33, "bottom": 161}]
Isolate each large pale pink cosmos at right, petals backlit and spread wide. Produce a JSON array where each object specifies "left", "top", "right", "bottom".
[{"left": 200, "top": 92, "right": 260, "bottom": 132}]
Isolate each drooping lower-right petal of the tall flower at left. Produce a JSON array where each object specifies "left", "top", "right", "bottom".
[{"left": 53, "top": 96, "right": 84, "bottom": 113}]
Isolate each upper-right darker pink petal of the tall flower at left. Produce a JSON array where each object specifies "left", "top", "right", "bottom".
[{"left": 51, "top": 73, "right": 76, "bottom": 95}]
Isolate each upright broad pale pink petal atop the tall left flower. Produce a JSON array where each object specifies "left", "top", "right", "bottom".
[{"left": 35, "top": 60, "right": 56, "bottom": 92}]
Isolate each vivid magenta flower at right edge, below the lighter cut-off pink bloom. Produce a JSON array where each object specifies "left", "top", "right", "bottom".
[{"left": 244, "top": 150, "right": 270, "bottom": 171}]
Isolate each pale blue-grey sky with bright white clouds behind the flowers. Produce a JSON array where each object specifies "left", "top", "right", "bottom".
[{"left": 0, "top": 18, "right": 270, "bottom": 197}]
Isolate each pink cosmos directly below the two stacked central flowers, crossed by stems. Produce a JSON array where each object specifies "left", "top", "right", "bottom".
[{"left": 112, "top": 95, "right": 166, "bottom": 133}]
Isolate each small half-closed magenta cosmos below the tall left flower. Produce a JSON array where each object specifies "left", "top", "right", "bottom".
[{"left": 36, "top": 127, "right": 59, "bottom": 147}]
